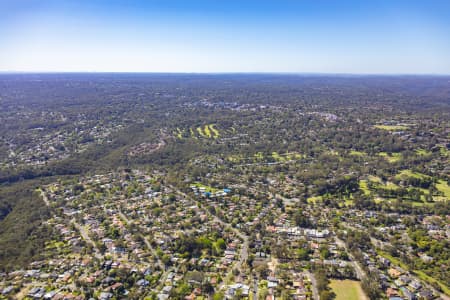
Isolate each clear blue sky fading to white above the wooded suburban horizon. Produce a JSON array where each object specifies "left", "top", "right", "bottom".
[{"left": 0, "top": 0, "right": 450, "bottom": 74}]
